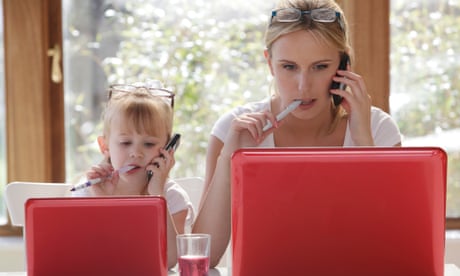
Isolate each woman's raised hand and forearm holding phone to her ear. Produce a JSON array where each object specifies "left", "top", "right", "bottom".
[{"left": 331, "top": 66, "right": 374, "bottom": 146}]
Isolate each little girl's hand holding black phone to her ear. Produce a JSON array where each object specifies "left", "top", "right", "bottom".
[{"left": 145, "top": 149, "right": 176, "bottom": 195}]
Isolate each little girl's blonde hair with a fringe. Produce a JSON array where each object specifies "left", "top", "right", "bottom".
[{"left": 102, "top": 88, "right": 173, "bottom": 139}]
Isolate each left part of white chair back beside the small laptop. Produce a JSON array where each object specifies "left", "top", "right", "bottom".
[{"left": 5, "top": 182, "right": 72, "bottom": 226}]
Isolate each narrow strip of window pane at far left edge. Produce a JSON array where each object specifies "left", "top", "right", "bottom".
[{"left": 0, "top": 1, "right": 6, "bottom": 225}]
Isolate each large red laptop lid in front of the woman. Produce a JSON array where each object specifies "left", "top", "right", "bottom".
[{"left": 231, "top": 148, "right": 447, "bottom": 276}]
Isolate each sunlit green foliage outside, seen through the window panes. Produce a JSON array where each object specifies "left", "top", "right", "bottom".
[{"left": 63, "top": 0, "right": 460, "bottom": 219}]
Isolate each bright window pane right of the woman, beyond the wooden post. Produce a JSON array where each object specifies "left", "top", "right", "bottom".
[{"left": 390, "top": 0, "right": 460, "bottom": 217}]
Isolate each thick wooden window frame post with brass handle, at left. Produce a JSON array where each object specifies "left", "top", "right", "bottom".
[{"left": 0, "top": 0, "right": 65, "bottom": 235}]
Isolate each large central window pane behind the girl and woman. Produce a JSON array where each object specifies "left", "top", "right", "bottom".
[{"left": 63, "top": 0, "right": 273, "bottom": 182}]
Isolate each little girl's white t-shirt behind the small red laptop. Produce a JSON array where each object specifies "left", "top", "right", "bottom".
[{"left": 72, "top": 179, "right": 195, "bottom": 229}]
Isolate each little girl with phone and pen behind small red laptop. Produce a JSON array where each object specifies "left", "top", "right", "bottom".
[{"left": 74, "top": 82, "right": 193, "bottom": 268}]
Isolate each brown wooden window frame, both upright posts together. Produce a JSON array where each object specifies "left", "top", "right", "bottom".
[{"left": 0, "top": 0, "right": 460, "bottom": 236}]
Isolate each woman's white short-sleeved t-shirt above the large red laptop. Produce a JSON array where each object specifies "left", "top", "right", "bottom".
[{"left": 211, "top": 99, "right": 401, "bottom": 148}]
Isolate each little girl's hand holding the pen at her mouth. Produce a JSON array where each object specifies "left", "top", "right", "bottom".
[{"left": 86, "top": 160, "right": 119, "bottom": 196}]
